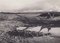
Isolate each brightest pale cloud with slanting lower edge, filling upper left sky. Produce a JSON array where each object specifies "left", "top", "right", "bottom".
[{"left": 0, "top": 0, "right": 43, "bottom": 11}]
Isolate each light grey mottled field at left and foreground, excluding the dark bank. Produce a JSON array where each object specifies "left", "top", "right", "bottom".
[{"left": 0, "top": 14, "right": 60, "bottom": 43}]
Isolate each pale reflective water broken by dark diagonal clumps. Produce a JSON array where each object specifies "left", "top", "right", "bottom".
[{"left": 17, "top": 26, "right": 60, "bottom": 36}]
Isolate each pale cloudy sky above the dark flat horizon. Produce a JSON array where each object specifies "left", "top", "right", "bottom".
[{"left": 0, "top": 0, "right": 60, "bottom": 11}]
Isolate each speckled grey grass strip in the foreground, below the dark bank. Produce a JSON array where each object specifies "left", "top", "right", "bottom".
[{"left": 0, "top": 32, "right": 60, "bottom": 43}]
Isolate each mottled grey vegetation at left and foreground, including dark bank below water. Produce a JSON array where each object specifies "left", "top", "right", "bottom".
[{"left": 0, "top": 14, "right": 60, "bottom": 43}]
